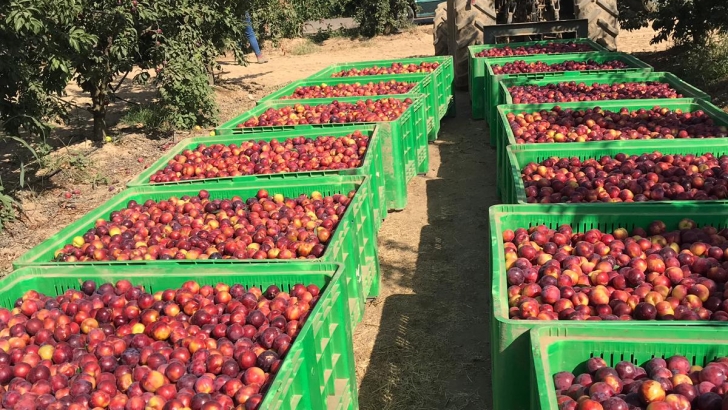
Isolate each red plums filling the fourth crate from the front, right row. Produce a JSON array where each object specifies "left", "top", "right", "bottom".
[{"left": 506, "top": 106, "right": 728, "bottom": 144}]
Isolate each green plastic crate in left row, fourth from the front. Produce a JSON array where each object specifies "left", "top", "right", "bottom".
[{"left": 215, "top": 95, "right": 430, "bottom": 210}]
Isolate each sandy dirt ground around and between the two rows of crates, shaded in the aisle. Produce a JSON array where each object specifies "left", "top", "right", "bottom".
[{"left": 0, "top": 23, "right": 665, "bottom": 410}]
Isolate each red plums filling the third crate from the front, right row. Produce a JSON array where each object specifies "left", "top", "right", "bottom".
[{"left": 521, "top": 152, "right": 728, "bottom": 203}]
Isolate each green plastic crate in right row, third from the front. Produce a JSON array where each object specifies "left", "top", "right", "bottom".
[{"left": 503, "top": 138, "right": 728, "bottom": 206}]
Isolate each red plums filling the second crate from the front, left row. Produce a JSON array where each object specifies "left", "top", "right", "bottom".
[{"left": 56, "top": 190, "right": 354, "bottom": 262}]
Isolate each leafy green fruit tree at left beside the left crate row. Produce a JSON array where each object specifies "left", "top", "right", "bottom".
[{"left": 0, "top": 0, "right": 248, "bottom": 139}]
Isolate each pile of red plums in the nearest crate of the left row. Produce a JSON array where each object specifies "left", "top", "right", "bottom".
[{"left": 0, "top": 280, "right": 319, "bottom": 410}]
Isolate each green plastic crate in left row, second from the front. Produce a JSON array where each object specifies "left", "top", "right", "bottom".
[{"left": 13, "top": 176, "right": 380, "bottom": 323}]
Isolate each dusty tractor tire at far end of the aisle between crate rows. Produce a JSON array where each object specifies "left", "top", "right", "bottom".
[{"left": 447, "top": 0, "right": 496, "bottom": 89}]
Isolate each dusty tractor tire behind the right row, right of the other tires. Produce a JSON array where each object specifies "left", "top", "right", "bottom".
[{"left": 574, "top": 0, "right": 619, "bottom": 50}]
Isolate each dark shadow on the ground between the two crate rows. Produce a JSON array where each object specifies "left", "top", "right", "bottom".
[{"left": 359, "top": 93, "right": 497, "bottom": 410}]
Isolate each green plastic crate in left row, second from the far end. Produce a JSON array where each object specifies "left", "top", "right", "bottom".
[{"left": 258, "top": 73, "right": 440, "bottom": 141}]
